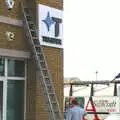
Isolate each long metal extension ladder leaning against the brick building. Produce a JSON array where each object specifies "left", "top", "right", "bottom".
[{"left": 21, "top": 4, "right": 62, "bottom": 120}]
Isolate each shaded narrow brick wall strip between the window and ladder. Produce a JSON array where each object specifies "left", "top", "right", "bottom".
[{"left": 25, "top": 59, "right": 37, "bottom": 120}]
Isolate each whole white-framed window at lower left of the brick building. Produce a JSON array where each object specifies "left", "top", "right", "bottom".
[{"left": 0, "top": 58, "right": 26, "bottom": 120}]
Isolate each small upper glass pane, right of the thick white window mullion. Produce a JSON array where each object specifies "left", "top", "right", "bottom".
[{"left": 8, "top": 60, "right": 25, "bottom": 77}]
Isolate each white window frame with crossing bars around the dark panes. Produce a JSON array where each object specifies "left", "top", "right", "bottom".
[{"left": 0, "top": 57, "right": 27, "bottom": 120}]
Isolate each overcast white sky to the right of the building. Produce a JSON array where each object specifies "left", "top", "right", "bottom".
[{"left": 64, "top": 0, "right": 120, "bottom": 80}]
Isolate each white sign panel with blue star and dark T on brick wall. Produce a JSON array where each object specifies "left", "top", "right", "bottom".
[{"left": 38, "top": 4, "right": 63, "bottom": 48}]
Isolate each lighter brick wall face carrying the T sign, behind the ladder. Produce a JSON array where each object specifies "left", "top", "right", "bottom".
[{"left": 25, "top": 0, "right": 64, "bottom": 120}]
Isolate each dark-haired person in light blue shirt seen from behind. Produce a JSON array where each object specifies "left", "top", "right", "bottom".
[{"left": 66, "top": 99, "right": 86, "bottom": 120}]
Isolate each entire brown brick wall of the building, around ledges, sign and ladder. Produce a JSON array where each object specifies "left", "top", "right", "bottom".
[{"left": 0, "top": 0, "right": 63, "bottom": 120}]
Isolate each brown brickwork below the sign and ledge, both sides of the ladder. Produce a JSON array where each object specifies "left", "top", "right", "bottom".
[{"left": 26, "top": 47, "right": 64, "bottom": 120}]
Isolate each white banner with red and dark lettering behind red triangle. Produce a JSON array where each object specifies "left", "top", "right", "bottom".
[{"left": 85, "top": 96, "right": 120, "bottom": 113}]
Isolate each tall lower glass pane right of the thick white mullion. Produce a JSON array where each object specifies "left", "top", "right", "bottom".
[{"left": 7, "top": 80, "right": 24, "bottom": 120}]
